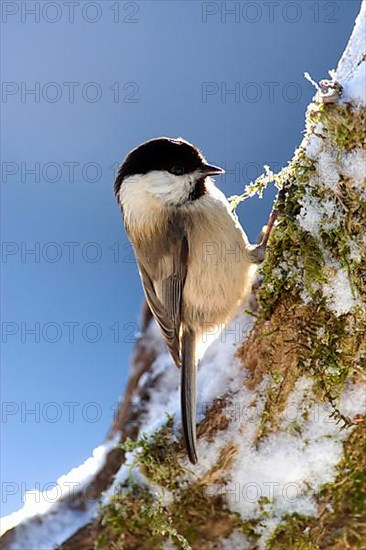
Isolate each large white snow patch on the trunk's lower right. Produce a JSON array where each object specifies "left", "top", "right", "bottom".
[{"left": 223, "top": 376, "right": 365, "bottom": 550}]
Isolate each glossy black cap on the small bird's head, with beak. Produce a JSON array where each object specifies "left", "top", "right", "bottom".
[{"left": 114, "top": 137, "right": 223, "bottom": 195}]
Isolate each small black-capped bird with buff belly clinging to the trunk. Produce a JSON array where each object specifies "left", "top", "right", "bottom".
[{"left": 114, "top": 137, "right": 267, "bottom": 464}]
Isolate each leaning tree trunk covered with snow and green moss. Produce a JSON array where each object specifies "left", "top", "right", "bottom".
[{"left": 3, "top": 2, "right": 366, "bottom": 550}]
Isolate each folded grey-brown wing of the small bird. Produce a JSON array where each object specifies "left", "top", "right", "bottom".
[{"left": 135, "top": 235, "right": 189, "bottom": 366}]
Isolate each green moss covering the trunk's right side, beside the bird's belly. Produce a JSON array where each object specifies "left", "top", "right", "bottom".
[{"left": 252, "top": 97, "right": 366, "bottom": 433}]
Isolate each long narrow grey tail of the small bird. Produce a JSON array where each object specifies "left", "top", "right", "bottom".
[{"left": 180, "top": 329, "right": 197, "bottom": 464}]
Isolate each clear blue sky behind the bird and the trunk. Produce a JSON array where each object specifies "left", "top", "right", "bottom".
[{"left": 1, "top": 0, "right": 360, "bottom": 514}]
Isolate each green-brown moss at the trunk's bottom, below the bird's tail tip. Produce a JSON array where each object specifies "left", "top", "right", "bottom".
[{"left": 96, "top": 418, "right": 247, "bottom": 550}]
